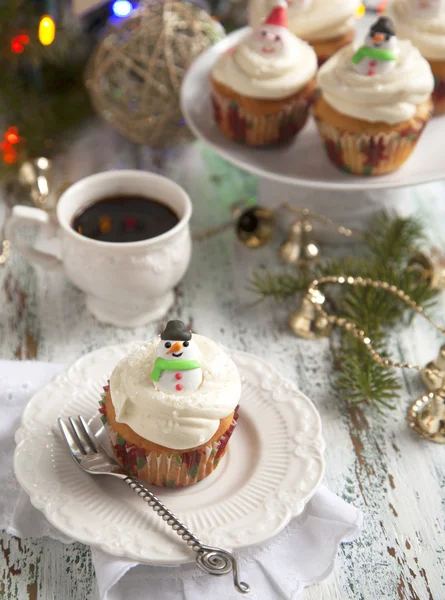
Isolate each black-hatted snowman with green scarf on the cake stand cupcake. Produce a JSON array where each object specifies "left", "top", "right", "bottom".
[{"left": 352, "top": 17, "right": 399, "bottom": 77}]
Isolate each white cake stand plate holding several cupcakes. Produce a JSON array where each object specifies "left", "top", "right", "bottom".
[{"left": 181, "top": 28, "right": 445, "bottom": 191}]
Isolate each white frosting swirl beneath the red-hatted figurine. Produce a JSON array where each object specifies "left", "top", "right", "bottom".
[{"left": 212, "top": 25, "right": 317, "bottom": 100}]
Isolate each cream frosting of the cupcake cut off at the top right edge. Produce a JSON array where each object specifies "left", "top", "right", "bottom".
[{"left": 387, "top": 0, "right": 445, "bottom": 60}]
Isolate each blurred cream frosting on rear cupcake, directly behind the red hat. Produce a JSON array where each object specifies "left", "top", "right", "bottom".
[{"left": 249, "top": 0, "right": 361, "bottom": 41}]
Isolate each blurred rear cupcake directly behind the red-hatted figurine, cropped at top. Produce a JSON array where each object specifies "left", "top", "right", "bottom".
[{"left": 249, "top": 0, "right": 361, "bottom": 65}]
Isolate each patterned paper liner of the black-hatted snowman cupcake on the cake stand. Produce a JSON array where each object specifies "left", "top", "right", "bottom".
[{"left": 316, "top": 118, "right": 427, "bottom": 176}]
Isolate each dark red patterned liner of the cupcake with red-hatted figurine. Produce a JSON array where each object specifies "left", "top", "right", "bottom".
[{"left": 212, "top": 89, "right": 311, "bottom": 147}]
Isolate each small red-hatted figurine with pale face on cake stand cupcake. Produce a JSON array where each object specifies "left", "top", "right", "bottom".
[{"left": 246, "top": 0, "right": 296, "bottom": 58}]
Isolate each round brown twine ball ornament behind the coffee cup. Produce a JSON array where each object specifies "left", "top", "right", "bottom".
[{"left": 86, "top": 0, "right": 224, "bottom": 149}]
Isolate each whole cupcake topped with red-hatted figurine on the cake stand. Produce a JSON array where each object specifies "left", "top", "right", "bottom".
[{"left": 211, "top": 0, "right": 317, "bottom": 147}]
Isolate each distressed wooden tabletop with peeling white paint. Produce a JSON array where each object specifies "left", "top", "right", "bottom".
[{"left": 0, "top": 123, "right": 445, "bottom": 600}]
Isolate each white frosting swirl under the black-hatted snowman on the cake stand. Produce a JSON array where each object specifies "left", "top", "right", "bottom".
[{"left": 318, "top": 41, "right": 434, "bottom": 124}]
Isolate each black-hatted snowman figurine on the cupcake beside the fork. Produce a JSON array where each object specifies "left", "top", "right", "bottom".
[{"left": 151, "top": 321, "right": 202, "bottom": 394}]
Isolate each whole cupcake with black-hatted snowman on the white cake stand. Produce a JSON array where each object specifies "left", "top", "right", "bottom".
[{"left": 313, "top": 17, "right": 434, "bottom": 175}]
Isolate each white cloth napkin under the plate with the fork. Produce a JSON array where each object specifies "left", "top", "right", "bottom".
[{"left": 0, "top": 361, "right": 363, "bottom": 600}]
